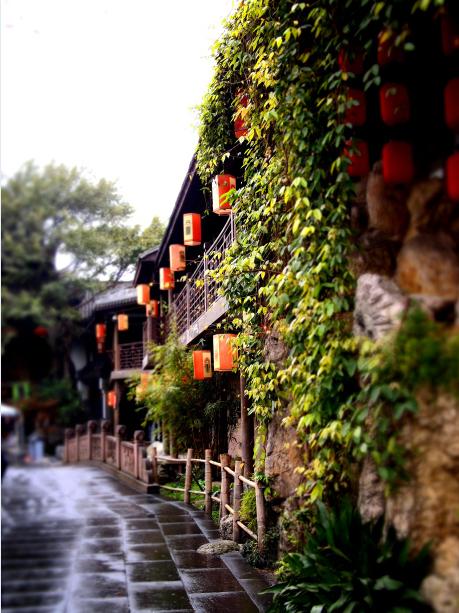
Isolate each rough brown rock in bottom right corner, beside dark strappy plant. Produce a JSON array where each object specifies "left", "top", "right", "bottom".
[{"left": 386, "top": 393, "right": 459, "bottom": 613}]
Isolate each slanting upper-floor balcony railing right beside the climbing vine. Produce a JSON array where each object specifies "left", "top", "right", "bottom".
[{"left": 174, "top": 215, "right": 235, "bottom": 342}]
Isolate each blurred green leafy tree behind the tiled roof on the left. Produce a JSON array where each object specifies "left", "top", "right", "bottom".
[{"left": 2, "top": 162, "right": 164, "bottom": 328}]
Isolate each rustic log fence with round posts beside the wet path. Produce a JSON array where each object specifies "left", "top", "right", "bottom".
[{"left": 151, "top": 449, "right": 266, "bottom": 551}]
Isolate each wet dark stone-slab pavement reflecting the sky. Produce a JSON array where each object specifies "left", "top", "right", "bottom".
[{"left": 2, "top": 466, "right": 274, "bottom": 613}]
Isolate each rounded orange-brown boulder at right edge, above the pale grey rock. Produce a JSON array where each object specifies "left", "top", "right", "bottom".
[{"left": 395, "top": 234, "right": 459, "bottom": 300}]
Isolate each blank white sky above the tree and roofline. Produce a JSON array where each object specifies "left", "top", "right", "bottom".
[{"left": 1, "top": 0, "right": 232, "bottom": 226}]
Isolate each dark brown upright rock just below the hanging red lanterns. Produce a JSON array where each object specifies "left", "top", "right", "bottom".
[{"left": 367, "top": 162, "right": 409, "bottom": 240}]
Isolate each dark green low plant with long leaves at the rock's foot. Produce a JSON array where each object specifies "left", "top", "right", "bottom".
[{"left": 268, "top": 500, "right": 431, "bottom": 613}]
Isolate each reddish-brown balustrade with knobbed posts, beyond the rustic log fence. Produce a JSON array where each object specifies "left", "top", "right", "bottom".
[{"left": 64, "top": 421, "right": 154, "bottom": 484}]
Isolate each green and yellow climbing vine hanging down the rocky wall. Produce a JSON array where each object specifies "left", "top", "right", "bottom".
[{"left": 197, "top": 0, "right": 450, "bottom": 516}]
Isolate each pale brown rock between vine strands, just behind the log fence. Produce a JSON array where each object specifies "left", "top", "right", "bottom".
[{"left": 265, "top": 414, "right": 304, "bottom": 498}]
